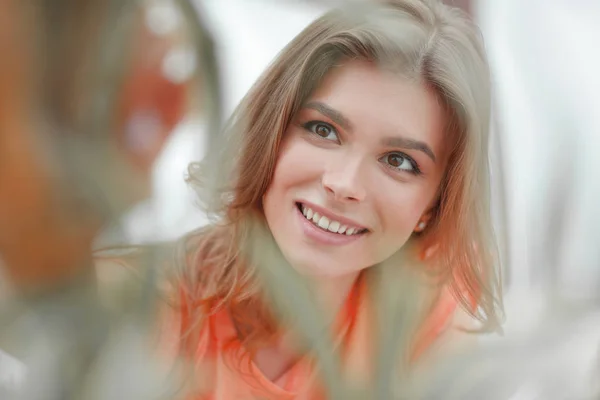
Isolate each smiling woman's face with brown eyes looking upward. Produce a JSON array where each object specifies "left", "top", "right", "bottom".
[{"left": 263, "top": 61, "right": 446, "bottom": 277}]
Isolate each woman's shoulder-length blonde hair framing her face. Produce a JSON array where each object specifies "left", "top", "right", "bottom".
[{"left": 179, "top": 0, "right": 500, "bottom": 356}]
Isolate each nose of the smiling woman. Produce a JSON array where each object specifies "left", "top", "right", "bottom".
[{"left": 321, "top": 160, "right": 367, "bottom": 202}]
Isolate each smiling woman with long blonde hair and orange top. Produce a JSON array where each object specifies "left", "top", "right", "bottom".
[{"left": 102, "top": 0, "right": 500, "bottom": 399}]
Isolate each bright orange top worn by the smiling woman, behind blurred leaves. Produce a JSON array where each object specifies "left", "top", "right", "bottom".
[{"left": 159, "top": 279, "right": 457, "bottom": 400}]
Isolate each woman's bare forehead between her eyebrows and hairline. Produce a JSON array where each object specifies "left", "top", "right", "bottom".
[{"left": 311, "top": 61, "right": 446, "bottom": 158}]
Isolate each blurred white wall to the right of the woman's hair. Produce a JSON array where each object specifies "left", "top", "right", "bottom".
[{"left": 477, "top": 0, "right": 600, "bottom": 328}]
